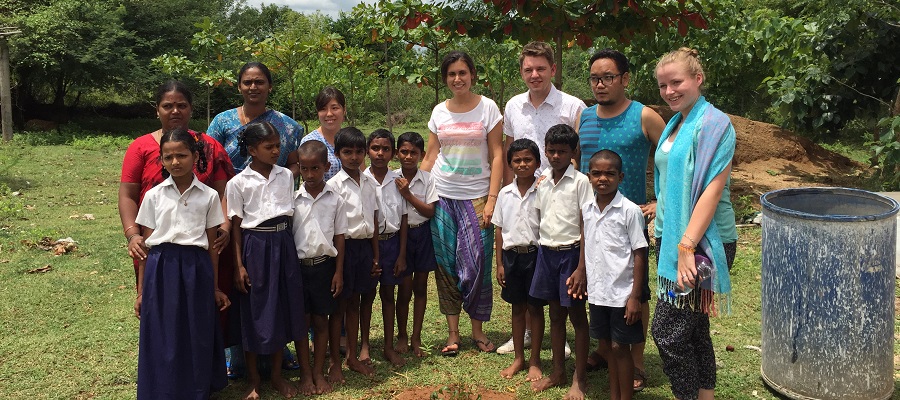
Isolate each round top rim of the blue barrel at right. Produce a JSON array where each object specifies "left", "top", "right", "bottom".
[{"left": 759, "top": 187, "right": 900, "bottom": 222}]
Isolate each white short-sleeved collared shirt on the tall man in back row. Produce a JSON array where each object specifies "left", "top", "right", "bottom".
[{"left": 503, "top": 84, "right": 587, "bottom": 176}]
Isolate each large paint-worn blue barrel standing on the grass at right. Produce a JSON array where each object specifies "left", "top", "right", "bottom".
[{"left": 761, "top": 188, "right": 900, "bottom": 400}]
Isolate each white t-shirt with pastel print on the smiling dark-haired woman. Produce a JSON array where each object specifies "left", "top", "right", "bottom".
[{"left": 428, "top": 96, "right": 503, "bottom": 200}]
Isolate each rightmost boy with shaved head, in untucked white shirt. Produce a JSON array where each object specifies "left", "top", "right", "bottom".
[{"left": 581, "top": 150, "right": 647, "bottom": 400}]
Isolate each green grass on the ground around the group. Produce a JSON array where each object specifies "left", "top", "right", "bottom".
[{"left": 0, "top": 134, "right": 900, "bottom": 399}]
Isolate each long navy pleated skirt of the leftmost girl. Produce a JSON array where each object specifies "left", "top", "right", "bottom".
[{"left": 137, "top": 243, "right": 228, "bottom": 400}]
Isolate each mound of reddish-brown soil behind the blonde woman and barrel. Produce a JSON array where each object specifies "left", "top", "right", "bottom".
[{"left": 650, "top": 106, "right": 866, "bottom": 206}]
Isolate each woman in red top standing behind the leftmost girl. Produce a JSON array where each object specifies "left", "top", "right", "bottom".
[{"left": 119, "top": 80, "right": 234, "bottom": 284}]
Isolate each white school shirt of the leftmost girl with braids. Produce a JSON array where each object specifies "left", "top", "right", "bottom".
[{"left": 134, "top": 175, "right": 225, "bottom": 249}]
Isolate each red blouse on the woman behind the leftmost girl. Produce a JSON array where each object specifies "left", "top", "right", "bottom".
[{"left": 121, "top": 131, "right": 234, "bottom": 204}]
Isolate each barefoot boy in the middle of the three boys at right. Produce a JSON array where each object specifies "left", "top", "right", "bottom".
[{"left": 529, "top": 124, "right": 593, "bottom": 400}]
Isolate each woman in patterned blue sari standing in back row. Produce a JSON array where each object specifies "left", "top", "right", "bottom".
[{"left": 206, "top": 62, "right": 303, "bottom": 177}]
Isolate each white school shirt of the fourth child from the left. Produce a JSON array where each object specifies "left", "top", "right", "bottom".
[{"left": 328, "top": 168, "right": 378, "bottom": 239}]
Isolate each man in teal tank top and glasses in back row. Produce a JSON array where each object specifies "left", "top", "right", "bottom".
[{"left": 577, "top": 49, "right": 666, "bottom": 391}]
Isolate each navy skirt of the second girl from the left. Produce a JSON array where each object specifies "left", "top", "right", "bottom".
[{"left": 238, "top": 218, "right": 306, "bottom": 354}]
